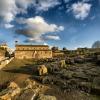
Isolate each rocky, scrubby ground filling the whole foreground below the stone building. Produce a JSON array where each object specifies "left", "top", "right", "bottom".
[{"left": 0, "top": 55, "right": 100, "bottom": 100}]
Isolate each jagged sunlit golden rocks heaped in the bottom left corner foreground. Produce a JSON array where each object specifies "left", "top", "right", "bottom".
[{"left": 0, "top": 79, "right": 56, "bottom": 100}]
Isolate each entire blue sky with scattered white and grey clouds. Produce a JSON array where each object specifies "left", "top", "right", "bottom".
[{"left": 0, "top": 0, "right": 100, "bottom": 49}]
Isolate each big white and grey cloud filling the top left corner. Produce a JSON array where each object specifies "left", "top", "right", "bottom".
[{"left": 0, "top": 0, "right": 32, "bottom": 28}]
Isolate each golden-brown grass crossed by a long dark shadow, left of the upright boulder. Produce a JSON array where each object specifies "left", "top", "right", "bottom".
[{"left": 0, "top": 59, "right": 35, "bottom": 85}]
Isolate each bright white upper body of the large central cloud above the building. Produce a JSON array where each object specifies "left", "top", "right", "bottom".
[{"left": 26, "top": 16, "right": 64, "bottom": 35}]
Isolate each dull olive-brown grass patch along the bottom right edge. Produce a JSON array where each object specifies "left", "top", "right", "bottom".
[{"left": 45, "top": 86, "right": 100, "bottom": 100}]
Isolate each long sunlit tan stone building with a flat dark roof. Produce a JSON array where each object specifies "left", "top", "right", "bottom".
[{"left": 15, "top": 45, "right": 52, "bottom": 59}]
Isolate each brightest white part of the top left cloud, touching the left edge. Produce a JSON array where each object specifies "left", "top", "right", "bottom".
[{"left": 0, "top": 0, "right": 17, "bottom": 23}]
